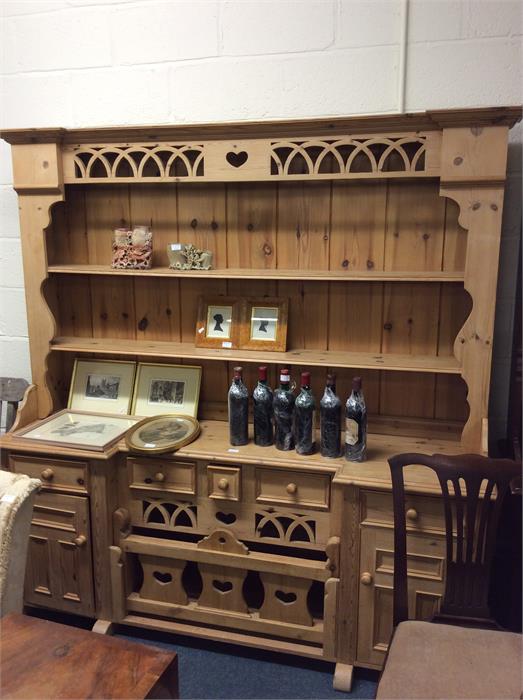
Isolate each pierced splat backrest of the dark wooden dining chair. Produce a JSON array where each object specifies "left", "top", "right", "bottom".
[{"left": 389, "top": 454, "right": 521, "bottom": 626}]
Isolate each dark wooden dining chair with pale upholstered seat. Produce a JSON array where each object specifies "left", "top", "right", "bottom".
[{"left": 377, "top": 454, "right": 522, "bottom": 700}]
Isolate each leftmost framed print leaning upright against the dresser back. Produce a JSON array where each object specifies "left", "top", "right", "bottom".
[{"left": 67, "top": 358, "right": 136, "bottom": 416}]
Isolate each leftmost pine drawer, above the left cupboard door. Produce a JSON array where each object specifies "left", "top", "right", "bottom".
[{"left": 9, "top": 455, "right": 89, "bottom": 493}]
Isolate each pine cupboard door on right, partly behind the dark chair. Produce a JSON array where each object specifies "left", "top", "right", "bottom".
[{"left": 357, "top": 527, "right": 445, "bottom": 666}]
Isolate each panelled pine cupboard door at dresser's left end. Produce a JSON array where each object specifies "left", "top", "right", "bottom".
[{"left": 25, "top": 493, "right": 94, "bottom": 615}]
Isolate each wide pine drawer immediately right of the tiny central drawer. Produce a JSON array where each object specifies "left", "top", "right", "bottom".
[{"left": 256, "top": 468, "right": 330, "bottom": 510}]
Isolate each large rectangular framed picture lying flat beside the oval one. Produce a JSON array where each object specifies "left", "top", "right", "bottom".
[{"left": 14, "top": 408, "right": 139, "bottom": 452}]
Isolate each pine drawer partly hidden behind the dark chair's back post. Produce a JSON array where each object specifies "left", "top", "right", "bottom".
[{"left": 361, "top": 491, "right": 445, "bottom": 533}]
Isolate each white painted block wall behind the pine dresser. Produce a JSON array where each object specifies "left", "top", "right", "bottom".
[{"left": 0, "top": 0, "right": 523, "bottom": 442}]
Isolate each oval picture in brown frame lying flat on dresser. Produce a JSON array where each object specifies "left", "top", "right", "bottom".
[{"left": 125, "top": 414, "right": 200, "bottom": 454}]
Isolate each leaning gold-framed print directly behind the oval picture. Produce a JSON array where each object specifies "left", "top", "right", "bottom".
[{"left": 131, "top": 362, "right": 202, "bottom": 418}]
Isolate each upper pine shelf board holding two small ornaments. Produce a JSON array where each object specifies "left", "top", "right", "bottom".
[{"left": 47, "top": 264, "right": 464, "bottom": 282}]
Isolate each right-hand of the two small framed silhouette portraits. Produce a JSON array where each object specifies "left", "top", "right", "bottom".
[{"left": 240, "top": 298, "right": 289, "bottom": 351}]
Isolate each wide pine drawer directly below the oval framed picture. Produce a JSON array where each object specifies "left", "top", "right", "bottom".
[{"left": 127, "top": 457, "right": 196, "bottom": 496}]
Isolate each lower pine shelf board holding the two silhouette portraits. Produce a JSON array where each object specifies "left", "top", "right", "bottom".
[{"left": 51, "top": 337, "right": 461, "bottom": 374}]
